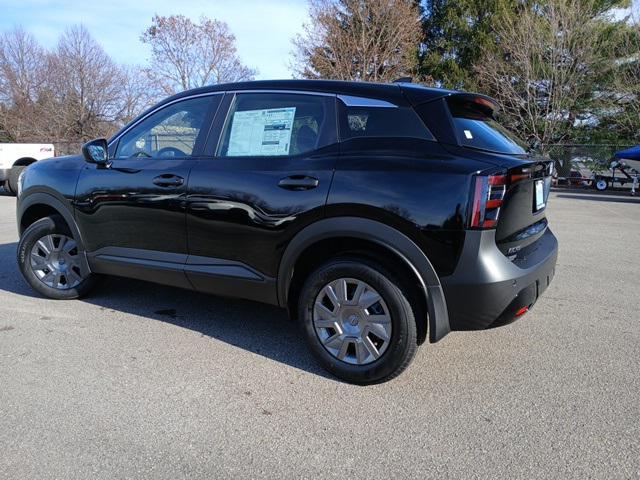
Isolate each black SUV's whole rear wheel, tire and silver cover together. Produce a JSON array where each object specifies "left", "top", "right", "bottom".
[{"left": 298, "top": 258, "right": 418, "bottom": 385}]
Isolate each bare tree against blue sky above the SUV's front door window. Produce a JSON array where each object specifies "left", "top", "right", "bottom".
[{"left": 141, "top": 15, "right": 256, "bottom": 94}]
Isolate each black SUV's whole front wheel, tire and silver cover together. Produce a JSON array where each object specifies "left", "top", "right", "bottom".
[{"left": 18, "top": 215, "right": 96, "bottom": 300}]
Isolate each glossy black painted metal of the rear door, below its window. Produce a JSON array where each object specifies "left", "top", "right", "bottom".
[{"left": 187, "top": 149, "right": 337, "bottom": 277}]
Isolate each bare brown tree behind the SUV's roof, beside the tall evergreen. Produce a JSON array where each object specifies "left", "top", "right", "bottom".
[{"left": 293, "top": 0, "right": 421, "bottom": 81}]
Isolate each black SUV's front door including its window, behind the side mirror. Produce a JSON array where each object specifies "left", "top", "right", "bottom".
[{"left": 76, "top": 94, "right": 222, "bottom": 286}]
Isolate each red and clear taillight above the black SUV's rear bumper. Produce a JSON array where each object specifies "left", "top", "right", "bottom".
[{"left": 470, "top": 174, "right": 507, "bottom": 228}]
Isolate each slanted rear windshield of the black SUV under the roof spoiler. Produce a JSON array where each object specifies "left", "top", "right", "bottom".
[{"left": 447, "top": 97, "right": 527, "bottom": 155}]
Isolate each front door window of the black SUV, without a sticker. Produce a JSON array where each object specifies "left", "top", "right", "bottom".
[{"left": 115, "top": 95, "right": 216, "bottom": 158}]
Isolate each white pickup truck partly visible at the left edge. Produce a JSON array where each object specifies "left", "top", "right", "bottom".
[{"left": 0, "top": 143, "right": 55, "bottom": 195}]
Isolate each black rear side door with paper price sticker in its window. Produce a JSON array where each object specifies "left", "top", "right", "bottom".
[{"left": 186, "top": 91, "right": 338, "bottom": 302}]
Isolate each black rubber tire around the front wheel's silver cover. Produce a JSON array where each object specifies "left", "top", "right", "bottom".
[{"left": 18, "top": 215, "right": 96, "bottom": 300}]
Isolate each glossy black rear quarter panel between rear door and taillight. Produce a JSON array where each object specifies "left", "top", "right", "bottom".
[{"left": 327, "top": 138, "right": 487, "bottom": 275}]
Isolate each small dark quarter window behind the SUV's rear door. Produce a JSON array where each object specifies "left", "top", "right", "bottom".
[{"left": 338, "top": 97, "right": 434, "bottom": 141}]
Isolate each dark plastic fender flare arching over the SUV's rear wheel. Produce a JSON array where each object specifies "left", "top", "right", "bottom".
[{"left": 277, "top": 217, "right": 451, "bottom": 343}]
